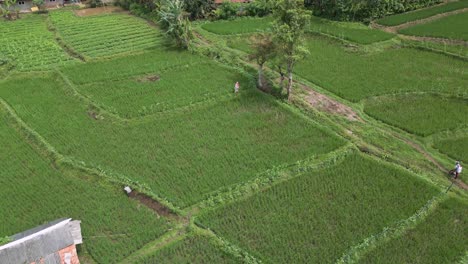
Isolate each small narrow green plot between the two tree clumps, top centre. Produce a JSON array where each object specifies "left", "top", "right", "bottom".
[{"left": 202, "top": 17, "right": 273, "bottom": 35}]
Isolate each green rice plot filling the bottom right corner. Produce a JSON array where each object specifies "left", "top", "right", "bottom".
[{"left": 360, "top": 198, "right": 468, "bottom": 264}]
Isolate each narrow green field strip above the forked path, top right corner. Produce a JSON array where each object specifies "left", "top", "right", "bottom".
[{"left": 377, "top": 0, "right": 468, "bottom": 26}]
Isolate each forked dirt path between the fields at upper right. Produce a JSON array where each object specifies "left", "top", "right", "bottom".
[{"left": 371, "top": 8, "right": 468, "bottom": 46}]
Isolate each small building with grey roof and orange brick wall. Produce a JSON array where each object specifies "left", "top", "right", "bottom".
[{"left": 0, "top": 218, "right": 83, "bottom": 264}]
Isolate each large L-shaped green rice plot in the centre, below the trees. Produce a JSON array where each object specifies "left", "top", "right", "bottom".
[{"left": 0, "top": 75, "right": 344, "bottom": 207}]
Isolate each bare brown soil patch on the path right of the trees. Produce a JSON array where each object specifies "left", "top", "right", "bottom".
[{"left": 300, "top": 84, "right": 363, "bottom": 122}]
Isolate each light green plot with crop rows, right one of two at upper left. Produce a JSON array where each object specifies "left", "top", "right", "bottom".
[{"left": 50, "top": 10, "right": 162, "bottom": 58}]
